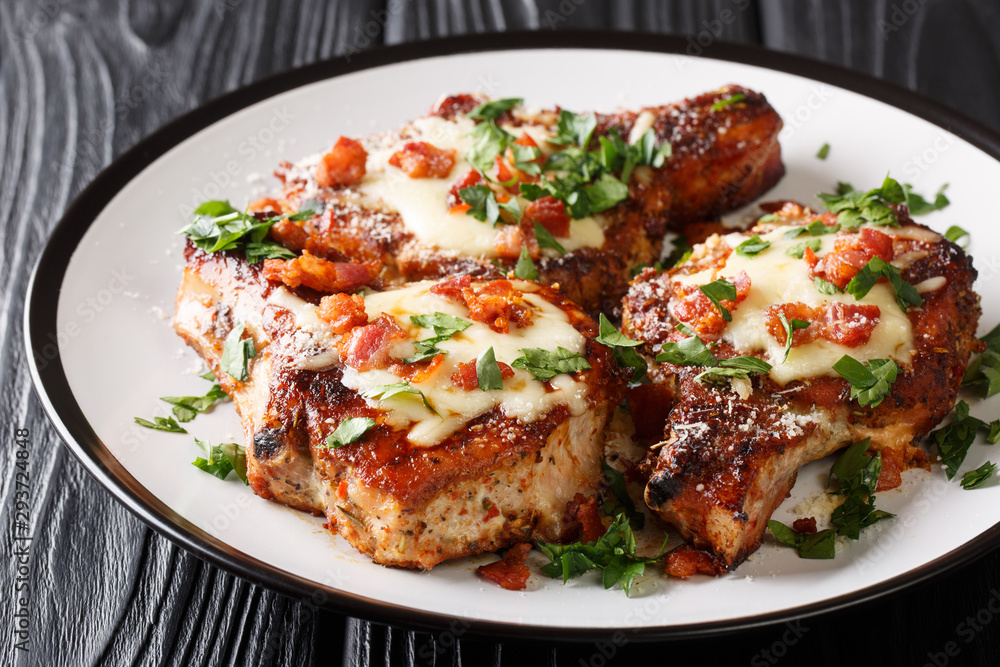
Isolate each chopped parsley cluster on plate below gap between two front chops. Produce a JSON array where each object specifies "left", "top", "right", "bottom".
[{"left": 538, "top": 514, "right": 666, "bottom": 595}]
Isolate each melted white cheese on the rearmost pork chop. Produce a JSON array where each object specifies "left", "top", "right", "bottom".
[{"left": 358, "top": 117, "right": 605, "bottom": 258}]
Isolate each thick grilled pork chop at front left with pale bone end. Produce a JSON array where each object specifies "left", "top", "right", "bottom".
[{"left": 175, "top": 244, "right": 624, "bottom": 568}]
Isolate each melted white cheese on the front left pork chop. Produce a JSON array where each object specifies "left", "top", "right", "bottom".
[{"left": 270, "top": 281, "right": 588, "bottom": 447}]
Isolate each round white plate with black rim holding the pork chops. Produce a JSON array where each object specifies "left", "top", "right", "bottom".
[{"left": 26, "top": 35, "right": 1000, "bottom": 637}]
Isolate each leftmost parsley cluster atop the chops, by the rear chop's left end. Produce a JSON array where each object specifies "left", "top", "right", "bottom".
[{"left": 180, "top": 201, "right": 316, "bottom": 264}]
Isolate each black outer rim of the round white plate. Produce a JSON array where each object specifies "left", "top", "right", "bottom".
[{"left": 24, "top": 31, "right": 1000, "bottom": 641}]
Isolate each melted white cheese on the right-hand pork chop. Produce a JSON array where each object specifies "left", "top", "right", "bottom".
[{"left": 676, "top": 227, "right": 913, "bottom": 385}]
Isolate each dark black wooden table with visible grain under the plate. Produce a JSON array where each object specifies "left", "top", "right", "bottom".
[{"left": 0, "top": 0, "right": 1000, "bottom": 666}]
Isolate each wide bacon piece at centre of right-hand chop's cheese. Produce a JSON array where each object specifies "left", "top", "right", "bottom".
[{"left": 764, "top": 302, "right": 882, "bottom": 347}]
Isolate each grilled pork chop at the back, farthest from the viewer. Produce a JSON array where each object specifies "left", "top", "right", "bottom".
[{"left": 257, "top": 86, "right": 784, "bottom": 313}]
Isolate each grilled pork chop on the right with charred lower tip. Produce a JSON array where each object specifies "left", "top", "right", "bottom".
[{"left": 623, "top": 204, "right": 980, "bottom": 567}]
